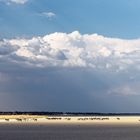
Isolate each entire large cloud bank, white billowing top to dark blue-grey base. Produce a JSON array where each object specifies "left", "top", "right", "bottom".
[{"left": 0, "top": 32, "right": 140, "bottom": 112}]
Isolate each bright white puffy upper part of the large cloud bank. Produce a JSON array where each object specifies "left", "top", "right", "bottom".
[{"left": 0, "top": 31, "right": 140, "bottom": 72}]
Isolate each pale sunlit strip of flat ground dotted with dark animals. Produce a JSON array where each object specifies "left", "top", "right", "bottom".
[{"left": 0, "top": 115, "right": 140, "bottom": 124}]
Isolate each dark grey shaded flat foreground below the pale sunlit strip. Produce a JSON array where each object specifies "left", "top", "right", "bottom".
[{"left": 0, "top": 124, "right": 140, "bottom": 140}]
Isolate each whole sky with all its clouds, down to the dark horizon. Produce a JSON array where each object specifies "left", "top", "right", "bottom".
[{"left": 0, "top": 0, "right": 140, "bottom": 113}]
